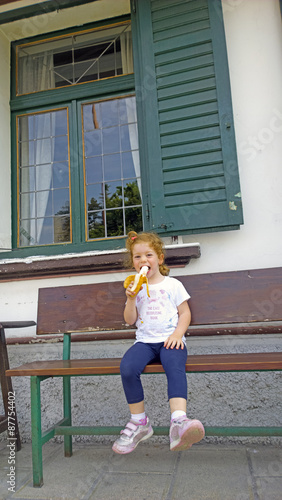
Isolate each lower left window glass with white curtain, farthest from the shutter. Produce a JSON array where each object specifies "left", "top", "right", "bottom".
[{"left": 17, "top": 109, "right": 71, "bottom": 247}]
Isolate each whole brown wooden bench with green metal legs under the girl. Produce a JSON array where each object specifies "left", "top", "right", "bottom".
[{"left": 6, "top": 268, "right": 282, "bottom": 486}]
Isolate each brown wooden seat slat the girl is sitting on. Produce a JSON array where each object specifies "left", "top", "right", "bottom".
[{"left": 6, "top": 352, "right": 282, "bottom": 376}]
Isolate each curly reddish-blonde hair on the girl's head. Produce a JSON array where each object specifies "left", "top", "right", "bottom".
[{"left": 125, "top": 231, "right": 169, "bottom": 276}]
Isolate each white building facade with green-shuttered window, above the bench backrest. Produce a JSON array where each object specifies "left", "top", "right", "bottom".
[{"left": 0, "top": 0, "right": 282, "bottom": 442}]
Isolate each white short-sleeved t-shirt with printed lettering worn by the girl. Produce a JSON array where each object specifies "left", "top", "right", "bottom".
[{"left": 136, "top": 276, "right": 190, "bottom": 343}]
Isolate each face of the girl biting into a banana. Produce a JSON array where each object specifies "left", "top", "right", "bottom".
[{"left": 132, "top": 243, "right": 164, "bottom": 283}]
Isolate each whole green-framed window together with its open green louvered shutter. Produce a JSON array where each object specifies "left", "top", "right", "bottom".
[{"left": 11, "top": 0, "right": 243, "bottom": 253}]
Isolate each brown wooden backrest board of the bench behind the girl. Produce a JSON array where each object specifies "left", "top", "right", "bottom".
[{"left": 37, "top": 268, "right": 282, "bottom": 337}]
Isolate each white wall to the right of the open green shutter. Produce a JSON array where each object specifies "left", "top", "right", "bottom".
[{"left": 184, "top": 0, "right": 282, "bottom": 274}]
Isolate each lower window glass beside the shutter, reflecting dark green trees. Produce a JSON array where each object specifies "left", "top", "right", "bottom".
[{"left": 82, "top": 96, "right": 143, "bottom": 240}]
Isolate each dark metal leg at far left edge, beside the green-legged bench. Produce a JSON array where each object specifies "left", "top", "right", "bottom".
[{"left": 0, "top": 325, "right": 21, "bottom": 451}]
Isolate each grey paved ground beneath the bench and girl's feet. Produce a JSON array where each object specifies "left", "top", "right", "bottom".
[{"left": 0, "top": 440, "right": 282, "bottom": 500}]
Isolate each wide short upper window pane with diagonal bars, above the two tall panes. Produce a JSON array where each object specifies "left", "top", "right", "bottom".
[{"left": 17, "top": 21, "right": 133, "bottom": 95}]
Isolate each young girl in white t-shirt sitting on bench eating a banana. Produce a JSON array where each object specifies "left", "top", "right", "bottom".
[{"left": 113, "top": 231, "right": 205, "bottom": 454}]
